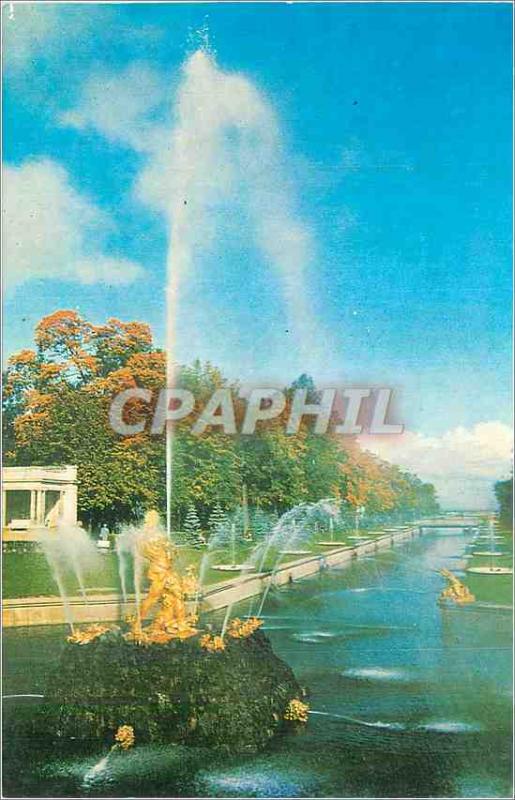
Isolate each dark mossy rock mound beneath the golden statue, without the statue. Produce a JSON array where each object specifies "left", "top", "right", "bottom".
[{"left": 38, "top": 630, "right": 302, "bottom": 752}]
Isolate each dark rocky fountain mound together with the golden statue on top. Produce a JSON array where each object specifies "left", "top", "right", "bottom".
[{"left": 37, "top": 520, "right": 307, "bottom": 752}]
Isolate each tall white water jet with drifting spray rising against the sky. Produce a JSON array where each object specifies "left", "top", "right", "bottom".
[{"left": 163, "top": 46, "right": 324, "bottom": 536}]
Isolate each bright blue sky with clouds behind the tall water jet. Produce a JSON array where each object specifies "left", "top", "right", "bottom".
[{"left": 4, "top": 4, "right": 512, "bottom": 506}]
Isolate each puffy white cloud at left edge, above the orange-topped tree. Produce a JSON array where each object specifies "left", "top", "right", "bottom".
[{"left": 2, "top": 159, "right": 142, "bottom": 288}]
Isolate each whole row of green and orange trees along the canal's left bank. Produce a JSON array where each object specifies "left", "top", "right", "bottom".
[{"left": 4, "top": 310, "right": 438, "bottom": 536}]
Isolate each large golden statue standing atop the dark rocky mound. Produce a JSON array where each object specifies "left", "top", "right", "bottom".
[{"left": 127, "top": 532, "right": 198, "bottom": 644}]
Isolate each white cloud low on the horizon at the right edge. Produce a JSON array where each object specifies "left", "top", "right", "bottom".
[{"left": 360, "top": 421, "right": 513, "bottom": 509}]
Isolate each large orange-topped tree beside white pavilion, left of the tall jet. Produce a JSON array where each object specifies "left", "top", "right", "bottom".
[{"left": 4, "top": 310, "right": 165, "bottom": 524}]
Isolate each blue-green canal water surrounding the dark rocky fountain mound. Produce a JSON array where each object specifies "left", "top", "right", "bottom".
[{"left": 4, "top": 531, "right": 512, "bottom": 798}]
